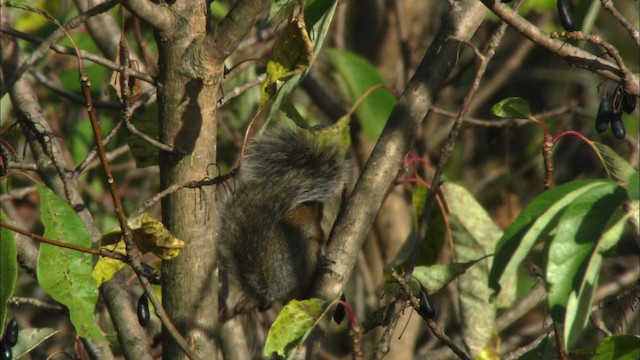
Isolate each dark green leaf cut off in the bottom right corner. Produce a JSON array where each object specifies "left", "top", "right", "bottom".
[{"left": 570, "top": 335, "right": 640, "bottom": 360}]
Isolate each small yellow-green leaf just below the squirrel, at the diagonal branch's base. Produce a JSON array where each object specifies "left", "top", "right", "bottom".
[{"left": 263, "top": 299, "right": 328, "bottom": 357}]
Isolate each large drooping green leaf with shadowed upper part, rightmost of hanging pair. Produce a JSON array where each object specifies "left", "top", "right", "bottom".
[{"left": 546, "top": 182, "right": 626, "bottom": 347}]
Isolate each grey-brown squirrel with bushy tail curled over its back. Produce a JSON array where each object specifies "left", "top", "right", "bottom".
[{"left": 218, "top": 125, "right": 349, "bottom": 316}]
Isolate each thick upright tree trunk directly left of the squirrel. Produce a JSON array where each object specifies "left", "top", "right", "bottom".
[{"left": 157, "top": 1, "right": 223, "bottom": 359}]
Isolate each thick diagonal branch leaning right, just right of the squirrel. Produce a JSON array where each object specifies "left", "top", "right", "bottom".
[{"left": 314, "top": 0, "right": 486, "bottom": 299}]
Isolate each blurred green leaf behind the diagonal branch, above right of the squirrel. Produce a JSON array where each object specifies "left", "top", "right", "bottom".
[{"left": 327, "top": 49, "right": 396, "bottom": 140}]
